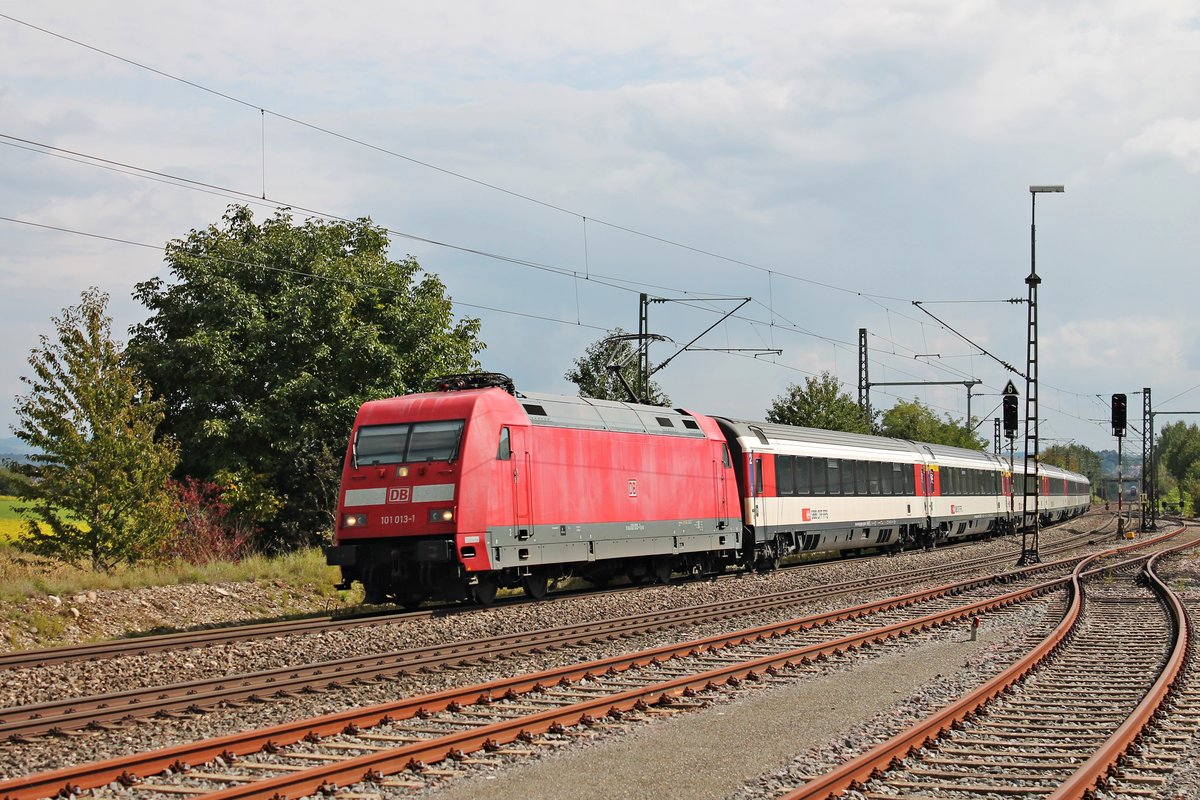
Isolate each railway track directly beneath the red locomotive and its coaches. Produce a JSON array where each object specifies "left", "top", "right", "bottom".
[{"left": 0, "top": 519, "right": 1112, "bottom": 670}]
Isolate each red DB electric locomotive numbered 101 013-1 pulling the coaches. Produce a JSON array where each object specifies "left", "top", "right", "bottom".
[{"left": 326, "top": 373, "right": 743, "bottom": 607}]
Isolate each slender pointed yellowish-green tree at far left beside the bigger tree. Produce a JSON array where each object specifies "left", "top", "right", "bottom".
[{"left": 13, "top": 288, "right": 179, "bottom": 570}]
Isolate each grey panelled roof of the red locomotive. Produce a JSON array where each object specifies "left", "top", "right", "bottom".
[{"left": 517, "top": 393, "right": 704, "bottom": 439}]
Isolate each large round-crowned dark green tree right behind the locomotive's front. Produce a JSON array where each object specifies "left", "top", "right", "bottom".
[{"left": 130, "top": 205, "right": 484, "bottom": 547}]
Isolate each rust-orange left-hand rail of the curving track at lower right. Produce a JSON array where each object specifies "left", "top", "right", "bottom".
[{"left": 776, "top": 527, "right": 1195, "bottom": 800}]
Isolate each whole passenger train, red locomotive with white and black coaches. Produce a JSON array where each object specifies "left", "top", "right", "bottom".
[{"left": 325, "top": 373, "right": 1091, "bottom": 608}]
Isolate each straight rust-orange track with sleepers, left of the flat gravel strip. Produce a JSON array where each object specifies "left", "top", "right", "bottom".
[{"left": 0, "top": 525, "right": 1180, "bottom": 800}]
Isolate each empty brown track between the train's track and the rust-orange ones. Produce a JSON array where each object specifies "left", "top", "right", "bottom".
[{"left": 0, "top": 525, "right": 1113, "bottom": 740}]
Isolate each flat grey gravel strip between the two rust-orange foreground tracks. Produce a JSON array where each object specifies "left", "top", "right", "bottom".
[{"left": 422, "top": 606, "right": 1045, "bottom": 800}]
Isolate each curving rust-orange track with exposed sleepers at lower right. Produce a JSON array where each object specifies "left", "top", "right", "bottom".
[{"left": 782, "top": 525, "right": 1200, "bottom": 800}]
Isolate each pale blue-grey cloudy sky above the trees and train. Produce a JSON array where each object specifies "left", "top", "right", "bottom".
[{"left": 0, "top": 0, "right": 1200, "bottom": 453}]
